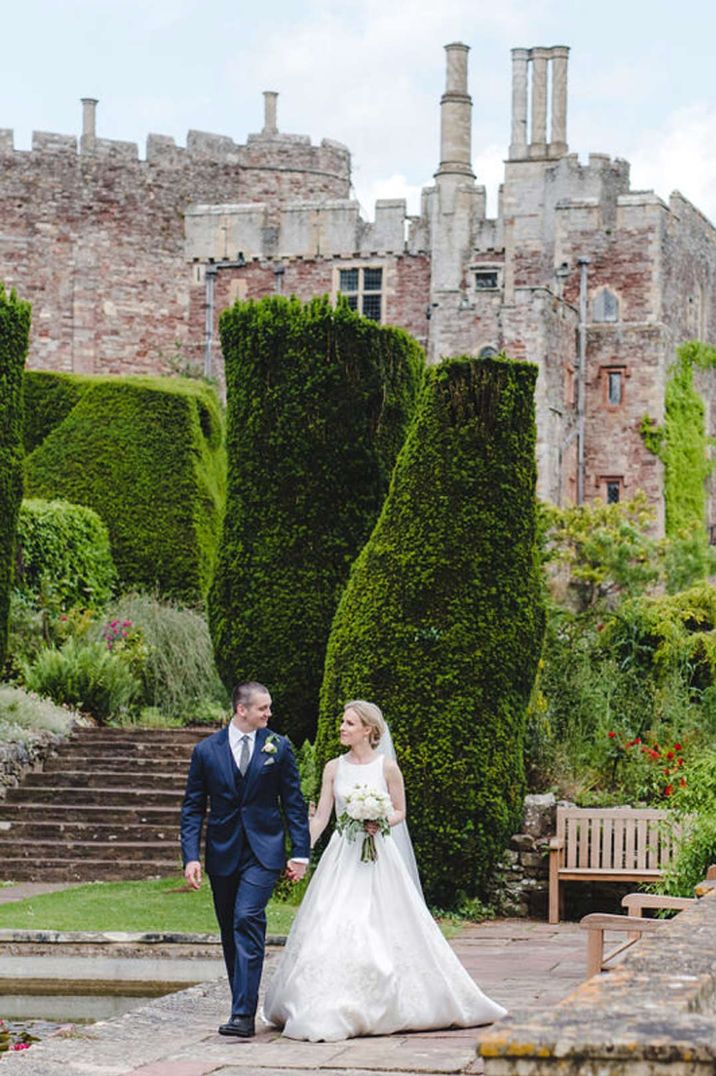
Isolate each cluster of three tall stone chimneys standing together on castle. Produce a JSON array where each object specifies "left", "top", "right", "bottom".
[{"left": 509, "top": 45, "right": 570, "bottom": 160}]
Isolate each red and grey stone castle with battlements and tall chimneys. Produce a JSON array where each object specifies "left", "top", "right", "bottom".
[{"left": 0, "top": 43, "right": 716, "bottom": 527}]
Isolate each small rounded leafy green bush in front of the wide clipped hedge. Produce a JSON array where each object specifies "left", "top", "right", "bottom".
[{"left": 15, "top": 500, "right": 116, "bottom": 611}]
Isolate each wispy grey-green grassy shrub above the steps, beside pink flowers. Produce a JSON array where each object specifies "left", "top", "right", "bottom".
[{"left": 90, "top": 594, "right": 228, "bottom": 724}]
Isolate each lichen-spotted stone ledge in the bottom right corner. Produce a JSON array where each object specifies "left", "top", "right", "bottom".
[{"left": 478, "top": 891, "right": 716, "bottom": 1076}]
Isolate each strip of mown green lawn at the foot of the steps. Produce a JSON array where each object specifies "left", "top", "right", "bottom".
[{"left": 0, "top": 875, "right": 297, "bottom": 934}]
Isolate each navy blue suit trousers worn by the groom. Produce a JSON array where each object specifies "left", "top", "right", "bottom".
[{"left": 209, "top": 840, "right": 281, "bottom": 1016}]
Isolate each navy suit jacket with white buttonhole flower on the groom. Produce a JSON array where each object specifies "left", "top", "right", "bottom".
[{"left": 181, "top": 727, "right": 311, "bottom": 876}]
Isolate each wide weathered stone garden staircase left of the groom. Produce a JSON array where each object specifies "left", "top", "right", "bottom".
[{"left": 0, "top": 728, "right": 211, "bottom": 881}]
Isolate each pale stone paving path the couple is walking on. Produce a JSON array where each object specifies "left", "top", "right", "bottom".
[{"left": 1, "top": 920, "right": 585, "bottom": 1076}]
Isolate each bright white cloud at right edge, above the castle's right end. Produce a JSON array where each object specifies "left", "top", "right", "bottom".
[{"left": 628, "top": 101, "right": 716, "bottom": 221}]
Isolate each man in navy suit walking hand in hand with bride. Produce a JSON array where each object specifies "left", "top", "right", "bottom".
[{"left": 181, "top": 681, "right": 310, "bottom": 1038}]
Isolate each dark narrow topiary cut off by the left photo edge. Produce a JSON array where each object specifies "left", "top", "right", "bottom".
[{"left": 0, "top": 283, "right": 30, "bottom": 670}]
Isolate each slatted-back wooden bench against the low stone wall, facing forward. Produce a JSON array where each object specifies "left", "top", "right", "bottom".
[{"left": 549, "top": 807, "right": 682, "bottom": 923}]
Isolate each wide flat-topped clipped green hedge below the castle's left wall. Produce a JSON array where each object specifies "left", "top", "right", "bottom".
[{"left": 25, "top": 373, "right": 225, "bottom": 601}]
